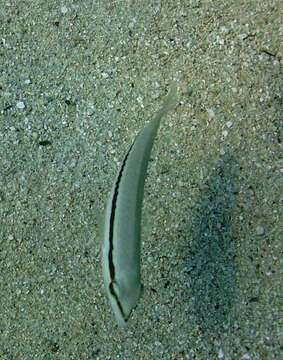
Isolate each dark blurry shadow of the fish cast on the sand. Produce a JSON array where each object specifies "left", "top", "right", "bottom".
[{"left": 187, "top": 155, "right": 241, "bottom": 333}]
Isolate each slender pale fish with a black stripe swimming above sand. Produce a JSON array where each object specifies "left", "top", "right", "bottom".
[{"left": 102, "top": 88, "right": 176, "bottom": 327}]
